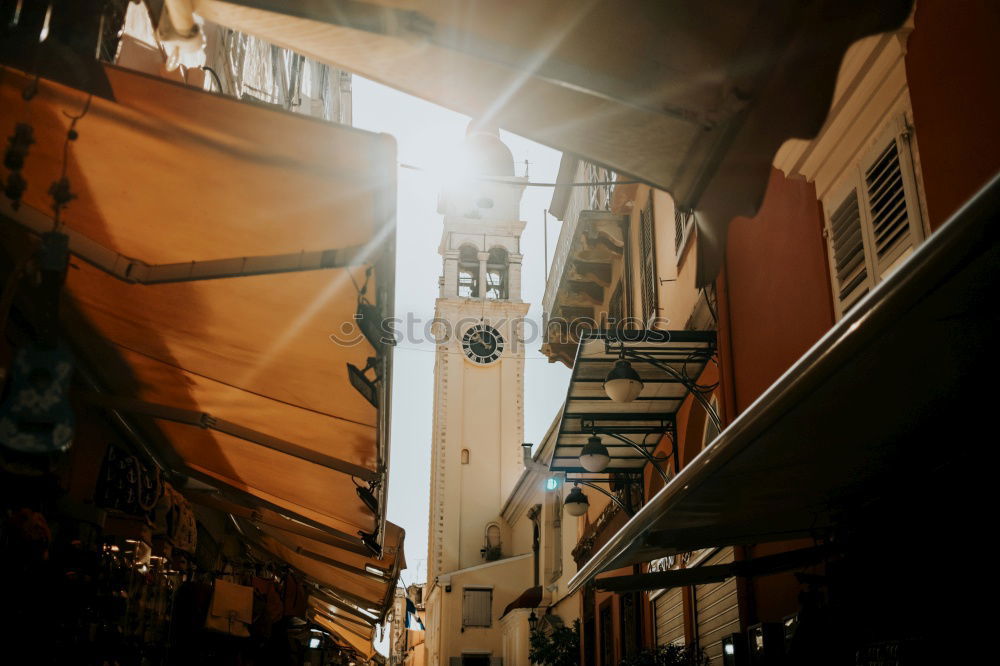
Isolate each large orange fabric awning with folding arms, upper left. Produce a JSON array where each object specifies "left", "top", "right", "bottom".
[{"left": 0, "top": 66, "right": 396, "bottom": 548}]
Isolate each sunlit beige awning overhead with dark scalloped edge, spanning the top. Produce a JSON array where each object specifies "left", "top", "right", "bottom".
[{"left": 194, "top": 0, "right": 912, "bottom": 285}]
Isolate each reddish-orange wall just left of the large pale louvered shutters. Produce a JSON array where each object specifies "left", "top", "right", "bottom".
[{"left": 716, "top": 169, "right": 834, "bottom": 623}]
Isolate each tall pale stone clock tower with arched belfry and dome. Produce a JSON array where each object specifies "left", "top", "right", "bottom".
[{"left": 427, "top": 125, "right": 528, "bottom": 663}]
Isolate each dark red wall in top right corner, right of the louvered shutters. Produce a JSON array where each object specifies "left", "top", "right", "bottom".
[{"left": 906, "top": 0, "right": 1000, "bottom": 230}]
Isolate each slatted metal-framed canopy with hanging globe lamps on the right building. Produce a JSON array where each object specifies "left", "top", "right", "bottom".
[{"left": 550, "top": 330, "right": 718, "bottom": 478}]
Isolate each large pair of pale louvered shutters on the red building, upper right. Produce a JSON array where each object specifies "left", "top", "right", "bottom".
[{"left": 824, "top": 118, "right": 924, "bottom": 316}]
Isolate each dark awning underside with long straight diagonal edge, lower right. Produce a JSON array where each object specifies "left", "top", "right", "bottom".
[{"left": 570, "top": 171, "right": 1000, "bottom": 590}]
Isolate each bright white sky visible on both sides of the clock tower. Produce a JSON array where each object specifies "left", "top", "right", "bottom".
[{"left": 353, "top": 76, "right": 569, "bottom": 600}]
